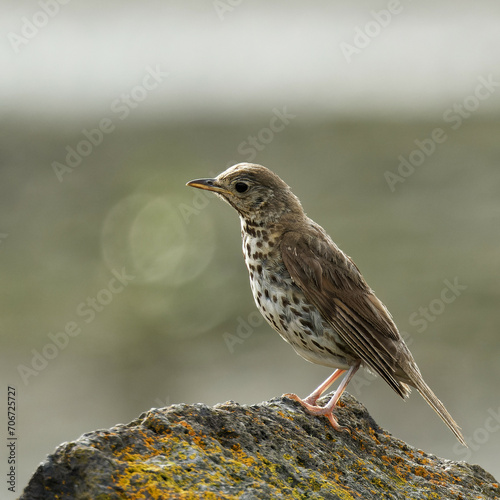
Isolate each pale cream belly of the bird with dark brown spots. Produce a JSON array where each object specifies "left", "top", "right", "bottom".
[{"left": 250, "top": 268, "right": 352, "bottom": 369}]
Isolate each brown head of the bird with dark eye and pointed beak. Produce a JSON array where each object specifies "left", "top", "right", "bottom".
[{"left": 187, "top": 163, "right": 303, "bottom": 222}]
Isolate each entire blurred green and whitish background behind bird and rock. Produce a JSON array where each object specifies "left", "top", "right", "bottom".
[{"left": 0, "top": 0, "right": 500, "bottom": 491}]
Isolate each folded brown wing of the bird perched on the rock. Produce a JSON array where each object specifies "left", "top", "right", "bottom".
[{"left": 281, "top": 226, "right": 410, "bottom": 397}]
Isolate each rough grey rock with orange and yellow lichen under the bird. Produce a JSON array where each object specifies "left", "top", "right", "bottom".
[{"left": 21, "top": 394, "right": 500, "bottom": 500}]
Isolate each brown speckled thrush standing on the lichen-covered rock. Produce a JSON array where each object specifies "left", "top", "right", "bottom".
[{"left": 187, "top": 163, "right": 467, "bottom": 446}]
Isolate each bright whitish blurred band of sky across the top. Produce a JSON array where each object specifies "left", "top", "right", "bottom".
[{"left": 0, "top": 0, "right": 500, "bottom": 119}]
